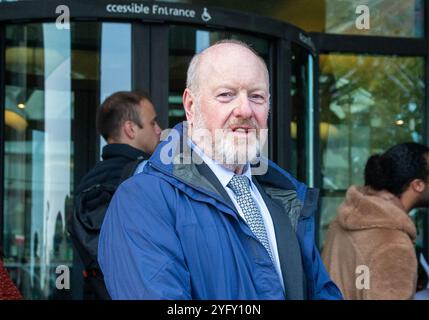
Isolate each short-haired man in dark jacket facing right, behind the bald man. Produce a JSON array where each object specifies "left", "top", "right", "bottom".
[{"left": 68, "top": 92, "right": 161, "bottom": 299}]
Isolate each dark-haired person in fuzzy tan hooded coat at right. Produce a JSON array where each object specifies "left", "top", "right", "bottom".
[{"left": 322, "top": 143, "right": 429, "bottom": 300}]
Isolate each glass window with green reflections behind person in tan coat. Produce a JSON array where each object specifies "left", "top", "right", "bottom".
[{"left": 320, "top": 54, "right": 425, "bottom": 243}]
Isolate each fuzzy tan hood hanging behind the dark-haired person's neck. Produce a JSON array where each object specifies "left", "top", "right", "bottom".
[{"left": 337, "top": 186, "right": 417, "bottom": 241}]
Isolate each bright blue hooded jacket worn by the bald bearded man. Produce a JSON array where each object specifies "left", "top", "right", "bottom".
[{"left": 98, "top": 124, "right": 341, "bottom": 300}]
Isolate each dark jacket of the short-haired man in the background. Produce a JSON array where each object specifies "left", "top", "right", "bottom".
[{"left": 68, "top": 144, "right": 148, "bottom": 299}]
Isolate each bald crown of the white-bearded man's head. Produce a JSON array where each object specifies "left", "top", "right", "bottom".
[{"left": 186, "top": 40, "right": 269, "bottom": 94}]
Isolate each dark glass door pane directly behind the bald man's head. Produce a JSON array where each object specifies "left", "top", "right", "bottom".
[{"left": 168, "top": 26, "right": 269, "bottom": 128}]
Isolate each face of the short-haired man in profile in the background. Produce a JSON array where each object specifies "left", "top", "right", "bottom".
[{"left": 135, "top": 99, "right": 161, "bottom": 154}]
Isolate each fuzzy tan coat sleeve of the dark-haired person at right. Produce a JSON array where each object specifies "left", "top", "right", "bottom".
[{"left": 363, "top": 244, "right": 417, "bottom": 300}]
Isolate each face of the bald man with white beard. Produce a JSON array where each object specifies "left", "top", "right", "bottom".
[{"left": 188, "top": 44, "right": 269, "bottom": 168}]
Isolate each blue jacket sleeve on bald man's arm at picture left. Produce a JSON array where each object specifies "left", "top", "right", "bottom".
[{"left": 98, "top": 174, "right": 191, "bottom": 300}]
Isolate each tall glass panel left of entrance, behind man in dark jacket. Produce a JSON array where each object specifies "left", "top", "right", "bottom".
[{"left": 2, "top": 22, "right": 131, "bottom": 299}]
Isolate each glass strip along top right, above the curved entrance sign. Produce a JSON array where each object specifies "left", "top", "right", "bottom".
[{"left": 173, "top": 0, "right": 425, "bottom": 38}]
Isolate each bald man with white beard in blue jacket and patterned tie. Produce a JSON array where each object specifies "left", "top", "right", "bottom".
[{"left": 99, "top": 40, "right": 341, "bottom": 300}]
